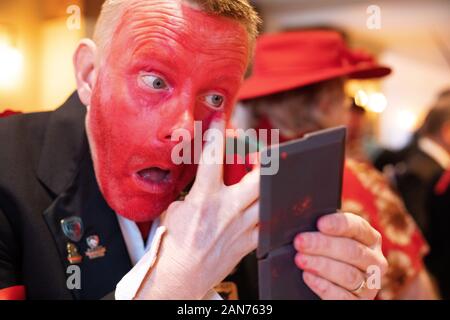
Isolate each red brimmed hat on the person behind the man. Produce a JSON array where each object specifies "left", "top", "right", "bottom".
[{"left": 238, "top": 30, "right": 391, "bottom": 100}]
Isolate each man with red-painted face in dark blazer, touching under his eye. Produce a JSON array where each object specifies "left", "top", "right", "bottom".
[{"left": 0, "top": 0, "right": 386, "bottom": 299}]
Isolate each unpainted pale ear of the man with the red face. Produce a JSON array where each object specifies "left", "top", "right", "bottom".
[{"left": 73, "top": 39, "right": 97, "bottom": 107}]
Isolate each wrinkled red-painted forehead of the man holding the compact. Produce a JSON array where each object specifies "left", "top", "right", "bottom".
[{"left": 115, "top": 0, "right": 248, "bottom": 55}]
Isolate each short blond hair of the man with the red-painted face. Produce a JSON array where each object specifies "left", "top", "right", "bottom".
[{"left": 94, "top": 0, "right": 261, "bottom": 57}]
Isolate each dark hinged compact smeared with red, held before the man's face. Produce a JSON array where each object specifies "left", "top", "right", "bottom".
[{"left": 257, "top": 127, "right": 346, "bottom": 300}]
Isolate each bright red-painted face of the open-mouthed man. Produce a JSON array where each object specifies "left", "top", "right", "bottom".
[{"left": 86, "top": 1, "right": 248, "bottom": 222}]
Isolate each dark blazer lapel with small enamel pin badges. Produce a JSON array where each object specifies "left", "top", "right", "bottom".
[{"left": 37, "top": 96, "right": 132, "bottom": 299}]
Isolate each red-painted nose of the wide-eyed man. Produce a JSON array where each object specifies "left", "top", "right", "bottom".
[{"left": 159, "top": 110, "right": 195, "bottom": 142}]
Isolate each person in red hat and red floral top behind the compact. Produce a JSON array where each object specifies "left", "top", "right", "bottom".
[{"left": 234, "top": 30, "right": 436, "bottom": 299}]
